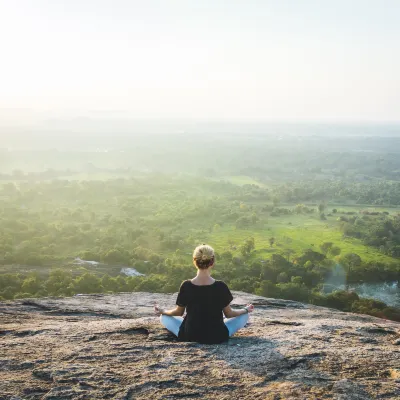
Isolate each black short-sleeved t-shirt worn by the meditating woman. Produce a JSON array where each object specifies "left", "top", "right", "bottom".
[{"left": 176, "top": 280, "right": 233, "bottom": 344}]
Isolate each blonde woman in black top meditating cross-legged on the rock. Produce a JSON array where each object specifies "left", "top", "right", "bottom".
[{"left": 154, "top": 244, "right": 254, "bottom": 344}]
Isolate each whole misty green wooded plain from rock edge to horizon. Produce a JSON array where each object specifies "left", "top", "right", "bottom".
[{"left": 0, "top": 131, "right": 400, "bottom": 319}]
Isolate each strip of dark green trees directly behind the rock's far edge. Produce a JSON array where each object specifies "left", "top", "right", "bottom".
[{"left": 0, "top": 268, "right": 400, "bottom": 322}]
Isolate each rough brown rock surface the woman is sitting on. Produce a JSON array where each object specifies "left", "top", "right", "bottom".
[{"left": 0, "top": 292, "right": 400, "bottom": 400}]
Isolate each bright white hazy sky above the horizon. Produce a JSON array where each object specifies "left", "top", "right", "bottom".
[{"left": 0, "top": 0, "right": 400, "bottom": 121}]
